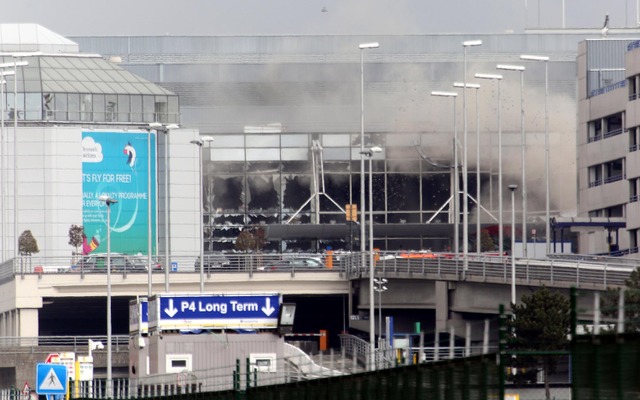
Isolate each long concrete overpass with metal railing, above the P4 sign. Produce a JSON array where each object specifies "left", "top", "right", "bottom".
[{"left": 0, "top": 254, "right": 635, "bottom": 337}]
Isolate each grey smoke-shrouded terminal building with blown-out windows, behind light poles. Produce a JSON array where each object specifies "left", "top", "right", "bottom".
[{"left": 72, "top": 30, "right": 624, "bottom": 251}]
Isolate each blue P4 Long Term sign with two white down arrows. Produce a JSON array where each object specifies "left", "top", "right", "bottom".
[{"left": 149, "top": 294, "right": 280, "bottom": 330}]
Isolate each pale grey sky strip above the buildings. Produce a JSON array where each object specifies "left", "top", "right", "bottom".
[{"left": 0, "top": 0, "right": 640, "bottom": 36}]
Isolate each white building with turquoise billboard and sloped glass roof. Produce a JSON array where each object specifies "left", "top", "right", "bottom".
[{"left": 0, "top": 24, "right": 200, "bottom": 267}]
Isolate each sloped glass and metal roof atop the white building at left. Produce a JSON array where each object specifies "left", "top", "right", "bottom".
[{"left": 0, "top": 24, "right": 180, "bottom": 124}]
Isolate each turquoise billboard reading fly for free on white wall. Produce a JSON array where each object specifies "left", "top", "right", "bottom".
[{"left": 82, "top": 131, "right": 157, "bottom": 255}]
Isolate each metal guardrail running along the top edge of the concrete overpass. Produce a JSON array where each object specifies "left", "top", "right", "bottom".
[{"left": 0, "top": 252, "right": 638, "bottom": 289}]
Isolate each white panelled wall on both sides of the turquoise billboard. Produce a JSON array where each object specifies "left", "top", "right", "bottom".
[{"left": 0, "top": 127, "right": 202, "bottom": 265}]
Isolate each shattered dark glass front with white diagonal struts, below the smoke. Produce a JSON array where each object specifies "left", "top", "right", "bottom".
[{"left": 203, "top": 133, "right": 482, "bottom": 251}]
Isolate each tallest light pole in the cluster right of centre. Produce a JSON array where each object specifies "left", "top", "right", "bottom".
[{"left": 462, "top": 40, "right": 482, "bottom": 268}]
